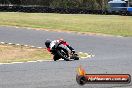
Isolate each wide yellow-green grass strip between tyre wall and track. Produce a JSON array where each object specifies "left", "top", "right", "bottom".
[{"left": 0, "top": 12, "right": 132, "bottom": 36}]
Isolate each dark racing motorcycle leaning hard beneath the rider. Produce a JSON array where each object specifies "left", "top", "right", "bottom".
[{"left": 52, "top": 43, "right": 79, "bottom": 61}]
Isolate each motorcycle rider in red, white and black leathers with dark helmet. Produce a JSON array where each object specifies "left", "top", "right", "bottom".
[{"left": 45, "top": 39, "right": 75, "bottom": 61}]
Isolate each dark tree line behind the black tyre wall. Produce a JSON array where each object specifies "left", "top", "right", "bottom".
[{"left": 0, "top": 0, "right": 109, "bottom": 10}]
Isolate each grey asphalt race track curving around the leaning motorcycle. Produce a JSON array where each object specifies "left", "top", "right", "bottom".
[{"left": 0, "top": 27, "right": 132, "bottom": 88}]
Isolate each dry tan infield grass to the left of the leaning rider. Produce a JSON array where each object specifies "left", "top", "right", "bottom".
[{"left": 0, "top": 45, "right": 51, "bottom": 63}]
